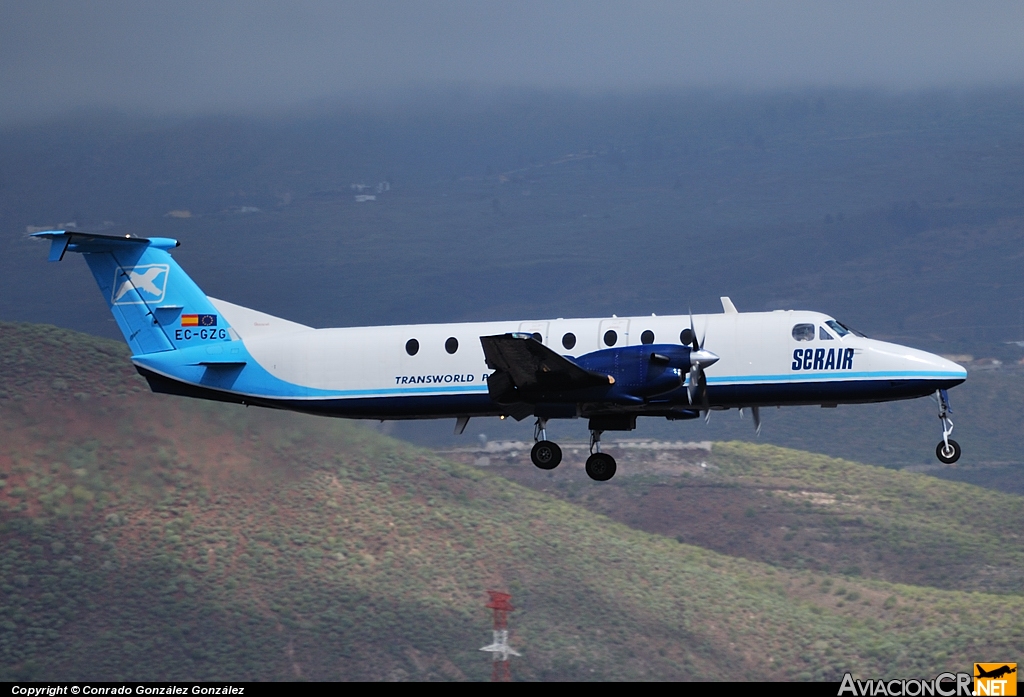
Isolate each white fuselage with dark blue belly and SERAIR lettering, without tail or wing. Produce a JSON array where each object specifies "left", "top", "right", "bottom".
[{"left": 136, "top": 299, "right": 967, "bottom": 419}]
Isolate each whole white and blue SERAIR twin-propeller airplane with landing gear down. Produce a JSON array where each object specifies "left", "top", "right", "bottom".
[{"left": 33, "top": 230, "right": 967, "bottom": 481}]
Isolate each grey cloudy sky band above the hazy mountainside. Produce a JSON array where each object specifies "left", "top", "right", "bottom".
[{"left": 0, "top": 0, "right": 1024, "bottom": 123}]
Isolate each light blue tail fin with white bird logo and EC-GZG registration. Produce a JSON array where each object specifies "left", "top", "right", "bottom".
[{"left": 33, "top": 230, "right": 234, "bottom": 355}]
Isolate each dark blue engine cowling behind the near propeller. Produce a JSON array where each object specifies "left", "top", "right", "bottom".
[{"left": 572, "top": 344, "right": 690, "bottom": 402}]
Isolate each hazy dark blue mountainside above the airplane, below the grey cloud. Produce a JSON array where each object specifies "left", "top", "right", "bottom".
[{"left": 6, "top": 90, "right": 1024, "bottom": 350}]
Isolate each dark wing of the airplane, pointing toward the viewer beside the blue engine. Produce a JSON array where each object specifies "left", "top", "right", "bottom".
[{"left": 480, "top": 334, "right": 614, "bottom": 399}]
